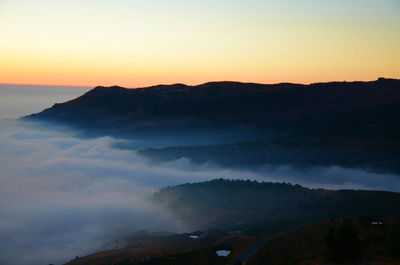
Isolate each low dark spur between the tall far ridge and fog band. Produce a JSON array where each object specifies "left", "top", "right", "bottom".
[{"left": 139, "top": 136, "right": 400, "bottom": 174}]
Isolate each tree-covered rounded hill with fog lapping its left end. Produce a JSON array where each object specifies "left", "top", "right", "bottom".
[{"left": 154, "top": 179, "right": 400, "bottom": 229}]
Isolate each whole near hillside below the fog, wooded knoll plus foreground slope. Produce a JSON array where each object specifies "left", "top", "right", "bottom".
[{"left": 67, "top": 179, "right": 400, "bottom": 265}]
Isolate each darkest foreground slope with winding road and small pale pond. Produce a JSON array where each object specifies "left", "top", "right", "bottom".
[{"left": 63, "top": 217, "right": 400, "bottom": 265}]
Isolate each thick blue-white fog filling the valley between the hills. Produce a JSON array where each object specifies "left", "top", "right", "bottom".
[{"left": 0, "top": 120, "right": 400, "bottom": 265}]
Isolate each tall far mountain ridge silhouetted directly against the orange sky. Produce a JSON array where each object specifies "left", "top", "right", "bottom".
[{"left": 27, "top": 78, "right": 400, "bottom": 139}]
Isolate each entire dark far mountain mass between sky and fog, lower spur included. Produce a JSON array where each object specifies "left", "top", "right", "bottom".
[{"left": 25, "top": 78, "right": 400, "bottom": 173}]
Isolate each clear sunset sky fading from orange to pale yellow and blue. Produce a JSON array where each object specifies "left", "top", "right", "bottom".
[{"left": 0, "top": 0, "right": 400, "bottom": 87}]
